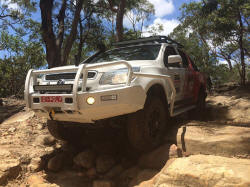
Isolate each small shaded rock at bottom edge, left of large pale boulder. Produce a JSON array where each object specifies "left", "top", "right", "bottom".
[{"left": 128, "top": 169, "right": 159, "bottom": 187}]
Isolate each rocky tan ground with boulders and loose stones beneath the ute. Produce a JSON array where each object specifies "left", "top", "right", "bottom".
[{"left": 0, "top": 86, "right": 250, "bottom": 187}]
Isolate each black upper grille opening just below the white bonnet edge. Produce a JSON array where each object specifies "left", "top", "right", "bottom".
[{"left": 45, "top": 71, "right": 96, "bottom": 80}]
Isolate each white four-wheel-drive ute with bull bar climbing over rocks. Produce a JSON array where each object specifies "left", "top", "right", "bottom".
[{"left": 25, "top": 36, "right": 206, "bottom": 151}]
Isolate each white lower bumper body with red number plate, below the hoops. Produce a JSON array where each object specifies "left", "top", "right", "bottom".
[{"left": 30, "top": 86, "right": 146, "bottom": 123}]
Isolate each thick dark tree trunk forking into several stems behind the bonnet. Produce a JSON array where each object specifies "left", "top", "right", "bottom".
[{"left": 40, "top": 0, "right": 83, "bottom": 68}]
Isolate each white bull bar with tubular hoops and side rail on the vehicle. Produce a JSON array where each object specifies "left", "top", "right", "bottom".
[{"left": 24, "top": 61, "right": 176, "bottom": 123}]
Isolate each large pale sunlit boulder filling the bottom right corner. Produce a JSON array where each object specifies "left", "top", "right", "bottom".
[{"left": 136, "top": 155, "right": 250, "bottom": 187}]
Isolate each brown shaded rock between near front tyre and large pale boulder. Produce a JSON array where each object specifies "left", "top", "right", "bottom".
[{"left": 138, "top": 144, "right": 173, "bottom": 169}]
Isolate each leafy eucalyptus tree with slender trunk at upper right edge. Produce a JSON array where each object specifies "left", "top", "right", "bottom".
[{"left": 174, "top": 0, "right": 250, "bottom": 85}]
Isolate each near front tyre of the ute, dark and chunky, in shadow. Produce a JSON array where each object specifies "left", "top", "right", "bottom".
[{"left": 127, "top": 96, "right": 168, "bottom": 152}]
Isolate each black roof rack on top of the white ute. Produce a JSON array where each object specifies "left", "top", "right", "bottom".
[{"left": 113, "top": 36, "right": 184, "bottom": 48}]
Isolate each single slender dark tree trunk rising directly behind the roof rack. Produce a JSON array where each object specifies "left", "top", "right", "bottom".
[{"left": 116, "top": 0, "right": 126, "bottom": 42}]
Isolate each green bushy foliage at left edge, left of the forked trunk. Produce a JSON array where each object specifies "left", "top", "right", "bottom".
[{"left": 0, "top": 32, "right": 46, "bottom": 97}]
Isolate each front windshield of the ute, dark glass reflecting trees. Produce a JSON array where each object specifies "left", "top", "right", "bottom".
[{"left": 88, "top": 45, "right": 161, "bottom": 63}]
